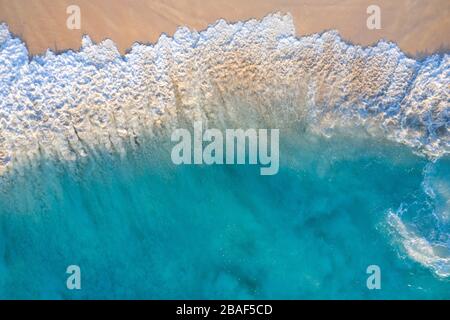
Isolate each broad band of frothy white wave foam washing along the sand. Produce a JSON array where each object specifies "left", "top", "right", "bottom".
[{"left": 0, "top": 14, "right": 450, "bottom": 175}]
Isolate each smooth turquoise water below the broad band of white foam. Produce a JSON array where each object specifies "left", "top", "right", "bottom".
[{"left": 0, "top": 131, "right": 450, "bottom": 299}]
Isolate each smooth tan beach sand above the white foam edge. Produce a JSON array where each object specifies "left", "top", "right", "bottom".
[{"left": 0, "top": 0, "right": 450, "bottom": 54}]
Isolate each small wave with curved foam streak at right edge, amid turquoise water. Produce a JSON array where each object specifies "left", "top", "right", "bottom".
[{"left": 387, "top": 160, "right": 450, "bottom": 278}]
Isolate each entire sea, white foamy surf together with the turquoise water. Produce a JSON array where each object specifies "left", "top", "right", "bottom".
[{"left": 0, "top": 14, "right": 450, "bottom": 298}]
